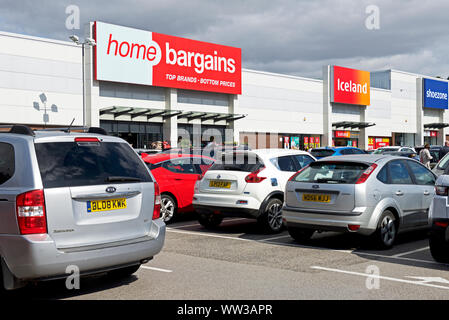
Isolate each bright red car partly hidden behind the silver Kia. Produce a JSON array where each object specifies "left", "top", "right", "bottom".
[{"left": 142, "top": 153, "right": 214, "bottom": 223}]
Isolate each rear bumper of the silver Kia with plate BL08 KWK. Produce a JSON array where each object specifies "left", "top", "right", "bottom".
[{"left": 0, "top": 219, "right": 165, "bottom": 280}]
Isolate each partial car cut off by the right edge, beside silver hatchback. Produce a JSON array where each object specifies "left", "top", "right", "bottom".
[{"left": 429, "top": 175, "right": 449, "bottom": 263}]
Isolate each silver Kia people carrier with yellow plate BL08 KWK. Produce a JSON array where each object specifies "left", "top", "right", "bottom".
[{"left": 0, "top": 126, "right": 165, "bottom": 289}]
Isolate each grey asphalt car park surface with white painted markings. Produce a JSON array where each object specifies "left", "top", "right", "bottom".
[{"left": 6, "top": 214, "right": 449, "bottom": 300}]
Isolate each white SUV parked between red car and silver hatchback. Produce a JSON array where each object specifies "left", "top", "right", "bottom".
[{"left": 193, "top": 149, "right": 316, "bottom": 232}]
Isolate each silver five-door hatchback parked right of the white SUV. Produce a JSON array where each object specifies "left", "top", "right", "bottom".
[{"left": 282, "top": 155, "right": 436, "bottom": 248}]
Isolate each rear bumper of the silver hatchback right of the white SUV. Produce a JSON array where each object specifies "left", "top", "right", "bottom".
[{"left": 282, "top": 206, "right": 376, "bottom": 235}]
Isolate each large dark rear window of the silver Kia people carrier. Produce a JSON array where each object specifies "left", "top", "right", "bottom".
[{"left": 35, "top": 142, "right": 152, "bottom": 188}]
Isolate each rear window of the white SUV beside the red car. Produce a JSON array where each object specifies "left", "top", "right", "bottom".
[{"left": 209, "top": 153, "right": 264, "bottom": 172}]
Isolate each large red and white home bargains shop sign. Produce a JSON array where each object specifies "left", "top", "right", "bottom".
[{"left": 94, "top": 21, "right": 242, "bottom": 94}]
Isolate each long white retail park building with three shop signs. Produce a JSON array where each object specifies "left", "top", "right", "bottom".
[{"left": 0, "top": 22, "right": 449, "bottom": 149}]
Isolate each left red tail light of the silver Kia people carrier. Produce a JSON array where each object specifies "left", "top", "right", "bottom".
[{"left": 16, "top": 190, "right": 47, "bottom": 234}]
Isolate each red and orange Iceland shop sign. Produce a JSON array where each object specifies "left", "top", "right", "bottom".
[{"left": 331, "top": 66, "right": 371, "bottom": 106}]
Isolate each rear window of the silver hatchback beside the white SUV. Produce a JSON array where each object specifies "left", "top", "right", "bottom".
[{"left": 293, "top": 161, "right": 368, "bottom": 184}]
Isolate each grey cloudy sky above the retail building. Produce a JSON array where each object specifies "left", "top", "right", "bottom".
[{"left": 0, "top": 0, "right": 449, "bottom": 78}]
